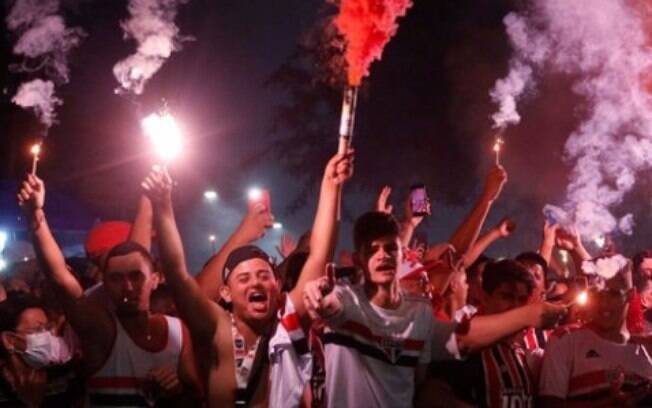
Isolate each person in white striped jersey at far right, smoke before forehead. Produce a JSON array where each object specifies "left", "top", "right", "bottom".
[{"left": 539, "top": 255, "right": 652, "bottom": 407}]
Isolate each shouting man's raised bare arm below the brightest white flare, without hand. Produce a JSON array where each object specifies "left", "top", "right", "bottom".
[{"left": 154, "top": 204, "right": 216, "bottom": 339}]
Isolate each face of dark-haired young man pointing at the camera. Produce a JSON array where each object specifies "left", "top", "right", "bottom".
[{"left": 361, "top": 235, "right": 403, "bottom": 285}]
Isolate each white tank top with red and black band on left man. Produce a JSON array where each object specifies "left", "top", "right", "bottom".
[{"left": 87, "top": 316, "right": 183, "bottom": 407}]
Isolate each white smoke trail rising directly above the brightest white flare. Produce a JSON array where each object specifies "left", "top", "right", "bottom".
[{"left": 113, "top": 0, "right": 191, "bottom": 95}]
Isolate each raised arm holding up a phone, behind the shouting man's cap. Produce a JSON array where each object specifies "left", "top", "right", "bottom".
[{"left": 195, "top": 203, "right": 274, "bottom": 300}]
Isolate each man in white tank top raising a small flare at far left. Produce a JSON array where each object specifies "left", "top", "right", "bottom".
[{"left": 18, "top": 175, "right": 200, "bottom": 407}]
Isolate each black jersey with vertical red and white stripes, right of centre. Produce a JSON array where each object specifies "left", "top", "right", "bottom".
[{"left": 430, "top": 342, "right": 537, "bottom": 408}]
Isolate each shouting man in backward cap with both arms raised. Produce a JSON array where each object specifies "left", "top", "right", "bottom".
[{"left": 142, "top": 151, "right": 353, "bottom": 407}]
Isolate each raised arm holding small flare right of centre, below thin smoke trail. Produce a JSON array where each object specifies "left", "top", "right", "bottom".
[{"left": 449, "top": 165, "right": 507, "bottom": 254}]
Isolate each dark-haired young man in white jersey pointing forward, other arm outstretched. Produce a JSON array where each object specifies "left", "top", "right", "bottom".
[{"left": 304, "top": 212, "right": 565, "bottom": 408}]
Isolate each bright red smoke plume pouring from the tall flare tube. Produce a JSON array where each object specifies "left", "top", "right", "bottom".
[{"left": 335, "top": 0, "right": 412, "bottom": 86}]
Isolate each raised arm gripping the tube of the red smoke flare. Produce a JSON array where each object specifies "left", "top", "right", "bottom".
[{"left": 290, "top": 150, "right": 353, "bottom": 317}]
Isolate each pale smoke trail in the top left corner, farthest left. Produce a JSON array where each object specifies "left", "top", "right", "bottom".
[{"left": 6, "top": 0, "right": 85, "bottom": 128}]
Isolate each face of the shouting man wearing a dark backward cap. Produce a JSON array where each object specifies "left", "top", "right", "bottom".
[{"left": 221, "top": 258, "right": 279, "bottom": 320}]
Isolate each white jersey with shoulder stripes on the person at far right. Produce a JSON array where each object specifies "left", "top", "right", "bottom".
[{"left": 539, "top": 327, "right": 652, "bottom": 399}]
